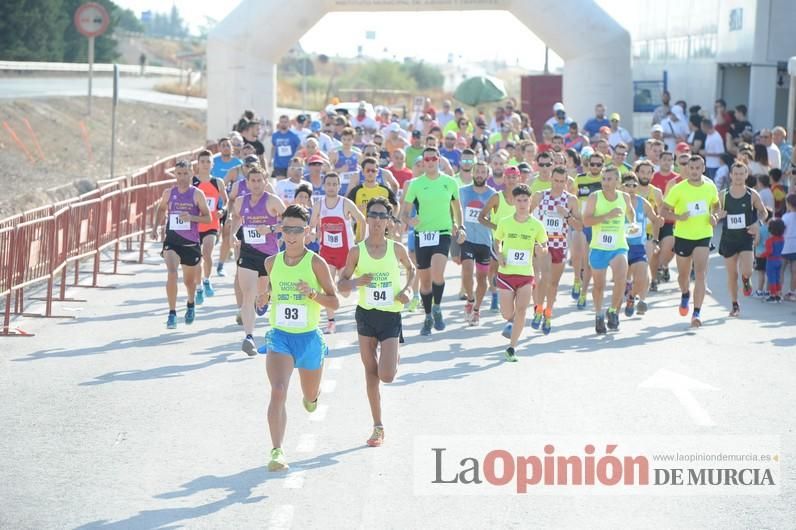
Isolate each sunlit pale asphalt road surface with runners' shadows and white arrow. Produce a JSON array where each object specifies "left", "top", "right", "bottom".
[{"left": 0, "top": 240, "right": 796, "bottom": 529}]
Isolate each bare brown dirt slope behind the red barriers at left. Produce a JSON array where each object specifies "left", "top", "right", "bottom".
[{"left": 0, "top": 97, "right": 205, "bottom": 219}]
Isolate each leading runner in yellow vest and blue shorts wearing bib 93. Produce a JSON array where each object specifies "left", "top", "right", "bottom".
[{"left": 258, "top": 204, "right": 340, "bottom": 471}]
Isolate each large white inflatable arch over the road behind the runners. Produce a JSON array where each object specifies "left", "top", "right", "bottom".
[{"left": 207, "top": 0, "right": 633, "bottom": 138}]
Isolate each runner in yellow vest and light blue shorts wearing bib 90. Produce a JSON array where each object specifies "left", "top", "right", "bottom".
[{"left": 583, "top": 166, "right": 636, "bottom": 334}]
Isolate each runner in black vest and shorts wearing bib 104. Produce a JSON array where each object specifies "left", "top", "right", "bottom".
[{"left": 718, "top": 162, "right": 768, "bottom": 317}]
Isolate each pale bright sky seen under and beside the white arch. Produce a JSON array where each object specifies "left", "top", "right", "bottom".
[{"left": 116, "top": 0, "right": 635, "bottom": 69}]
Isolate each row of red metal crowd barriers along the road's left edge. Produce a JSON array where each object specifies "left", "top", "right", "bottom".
[{"left": 0, "top": 146, "right": 215, "bottom": 336}]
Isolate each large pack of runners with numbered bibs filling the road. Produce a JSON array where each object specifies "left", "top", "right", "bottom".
[{"left": 152, "top": 100, "right": 796, "bottom": 471}]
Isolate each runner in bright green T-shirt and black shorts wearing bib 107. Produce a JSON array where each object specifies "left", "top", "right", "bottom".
[{"left": 401, "top": 147, "right": 466, "bottom": 335}]
